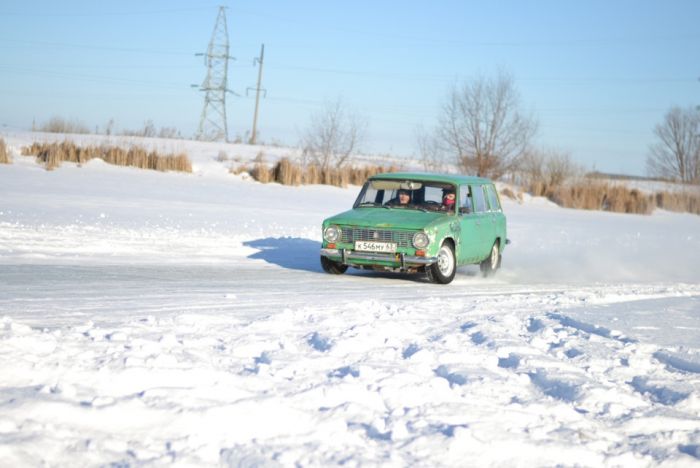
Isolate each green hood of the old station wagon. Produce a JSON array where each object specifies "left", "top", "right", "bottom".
[{"left": 326, "top": 208, "right": 452, "bottom": 230}]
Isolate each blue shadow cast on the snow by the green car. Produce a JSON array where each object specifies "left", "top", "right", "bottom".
[{"left": 243, "top": 237, "right": 323, "bottom": 272}]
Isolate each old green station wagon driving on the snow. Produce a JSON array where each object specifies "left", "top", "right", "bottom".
[{"left": 321, "top": 172, "right": 508, "bottom": 284}]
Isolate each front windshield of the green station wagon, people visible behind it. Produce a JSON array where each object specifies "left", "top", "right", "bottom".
[{"left": 354, "top": 179, "right": 456, "bottom": 212}]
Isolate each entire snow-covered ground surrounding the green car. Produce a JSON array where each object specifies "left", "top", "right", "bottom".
[{"left": 0, "top": 136, "right": 700, "bottom": 467}]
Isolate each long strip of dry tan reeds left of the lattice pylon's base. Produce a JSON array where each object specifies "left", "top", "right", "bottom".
[{"left": 22, "top": 141, "right": 192, "bottom": 172}]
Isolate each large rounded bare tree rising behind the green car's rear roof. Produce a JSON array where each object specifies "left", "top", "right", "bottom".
[{"left": 438, "top": 73, "right": 537, "bottom": 178}]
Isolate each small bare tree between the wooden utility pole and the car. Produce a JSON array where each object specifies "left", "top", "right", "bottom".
[{"left": 301, "top": 98, "right": 366, "bottom": 171}]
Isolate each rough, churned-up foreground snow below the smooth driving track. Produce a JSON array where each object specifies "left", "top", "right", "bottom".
[{"left": 0, "top": 288, "right": 700, "bottom": 466}]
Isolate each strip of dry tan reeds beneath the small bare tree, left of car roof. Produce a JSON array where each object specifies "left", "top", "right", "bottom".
[{"left": 231, "top": 157, "right": 400, "bottom": 187}]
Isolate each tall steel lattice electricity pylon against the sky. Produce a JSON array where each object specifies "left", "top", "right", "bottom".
[{"left": 195, "top": 6, "right": 235, "bottom": 141}]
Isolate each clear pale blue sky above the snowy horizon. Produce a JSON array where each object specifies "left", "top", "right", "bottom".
[{"left": 0, "top": 0, "right": 700, "bottom": 175}]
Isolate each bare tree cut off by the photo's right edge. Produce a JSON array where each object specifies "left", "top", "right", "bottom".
[{"left": 647, "top": 107, "right": 700, "bottom": 182}]
